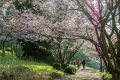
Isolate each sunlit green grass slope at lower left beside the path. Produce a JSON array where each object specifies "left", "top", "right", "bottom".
[{"left": 0, "top": 56, "right": 64, "bottom": 80}]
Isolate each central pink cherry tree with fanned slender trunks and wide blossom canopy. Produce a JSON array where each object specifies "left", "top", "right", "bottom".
[{"left": 4, "top": 0, "right": 83, "bottom": 64}]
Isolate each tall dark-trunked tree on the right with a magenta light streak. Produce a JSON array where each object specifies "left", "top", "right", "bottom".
[{"left": 73, "top": 0, "right": 120, "bottom": 80}]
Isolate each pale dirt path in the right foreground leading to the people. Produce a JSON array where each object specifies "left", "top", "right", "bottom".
[{"left": 68, "top": 68, "right": 102, "bottom": 80}]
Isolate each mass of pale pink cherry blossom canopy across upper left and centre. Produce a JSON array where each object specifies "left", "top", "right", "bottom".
[{"left": 0, "top": 0, "right": 101, "bottom": 66}]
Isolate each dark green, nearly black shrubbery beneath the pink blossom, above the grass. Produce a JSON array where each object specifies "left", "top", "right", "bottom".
[{"left": 19, "top": 39, "right": 54, "bottom": 64}]
